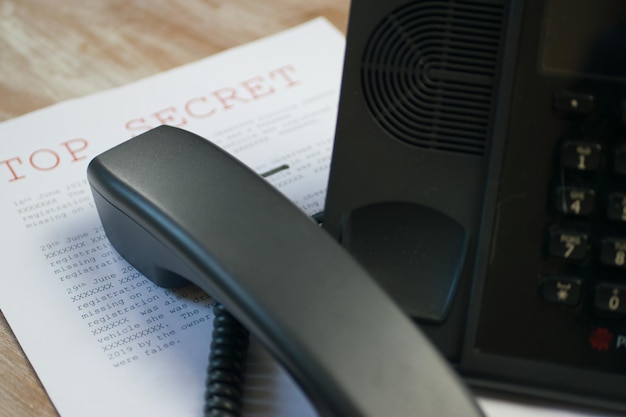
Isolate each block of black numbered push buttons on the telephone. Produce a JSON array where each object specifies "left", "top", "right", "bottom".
[{"left": 540, "top": 93, "right": 626, "bottom": 316}]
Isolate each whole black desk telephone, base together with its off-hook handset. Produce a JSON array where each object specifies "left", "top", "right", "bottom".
[{"left": 89, "top": 0, "right": 626, "bottom": 416}]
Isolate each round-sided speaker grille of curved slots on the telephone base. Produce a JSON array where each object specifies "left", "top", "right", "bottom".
[{"left": 361, "top": 0, "right": 504, "bottom": 155}]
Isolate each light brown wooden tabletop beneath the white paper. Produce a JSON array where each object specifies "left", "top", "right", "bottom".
[{"left": 0, "top": 0, "right": 349, "bottom": 417}]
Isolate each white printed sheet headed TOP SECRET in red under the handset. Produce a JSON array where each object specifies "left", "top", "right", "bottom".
[{"left": 0, "top": 19, "right": 345, "bottom": 417}]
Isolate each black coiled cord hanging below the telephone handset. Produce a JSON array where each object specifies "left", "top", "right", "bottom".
[{"left": 204, "top": 303, "right": 249, "bottom": 417}]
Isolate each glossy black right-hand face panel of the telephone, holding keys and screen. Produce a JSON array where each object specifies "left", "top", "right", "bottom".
[{"left": 467, "top": 6, "right": 626, "bottom": 402}]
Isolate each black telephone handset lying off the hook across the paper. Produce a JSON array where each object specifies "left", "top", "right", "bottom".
[{"left": 88, "top": 126, "right": 482, "bottom": 417}]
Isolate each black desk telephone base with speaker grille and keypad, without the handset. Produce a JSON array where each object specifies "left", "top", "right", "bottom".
[{"left": 324, "top": 0, "right": 626, "bottom": 411}]
